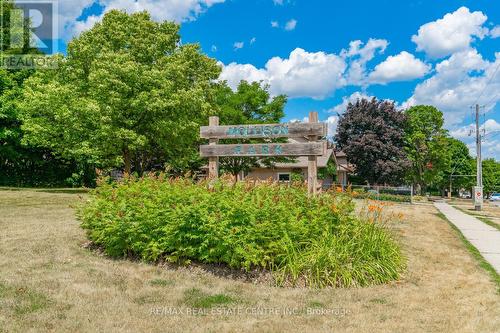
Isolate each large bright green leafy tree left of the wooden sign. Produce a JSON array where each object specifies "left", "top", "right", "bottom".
[{"left": 22, "top": 10, "right": 220, "bottom": 173}]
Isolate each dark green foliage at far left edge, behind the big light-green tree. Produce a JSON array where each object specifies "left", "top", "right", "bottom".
[{"left": 0, "top": 1, "right": 92, "bottom": 186}]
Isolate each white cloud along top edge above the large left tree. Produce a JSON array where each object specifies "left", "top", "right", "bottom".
[{"left": 66, "top": 0, "right": 225, "bottom": 39}]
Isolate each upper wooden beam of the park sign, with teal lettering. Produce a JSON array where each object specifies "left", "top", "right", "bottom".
[{"left": 200, "top": 123, "right": 328, "bottom": 139}]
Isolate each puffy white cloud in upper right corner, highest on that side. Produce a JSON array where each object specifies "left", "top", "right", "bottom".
[{"left": 412, "top": 7, "right": 488, "bottom": 58}]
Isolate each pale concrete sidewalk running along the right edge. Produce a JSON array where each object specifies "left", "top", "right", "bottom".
[{"left": 434, "top": 202, "right": 500, "bottom": 273}]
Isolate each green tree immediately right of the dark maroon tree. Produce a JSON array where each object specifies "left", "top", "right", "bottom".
[{"left": 405, "top": 105, "right": 451, "bottom": 193}]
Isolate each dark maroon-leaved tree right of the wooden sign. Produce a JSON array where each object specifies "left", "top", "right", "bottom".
[{"left": 335, "top": 98, "right": 408, "bottom": 185}]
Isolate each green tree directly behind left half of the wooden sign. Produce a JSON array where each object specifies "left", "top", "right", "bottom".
[{"left": 216, "top": 81, "right": 287, "bottom": 177}]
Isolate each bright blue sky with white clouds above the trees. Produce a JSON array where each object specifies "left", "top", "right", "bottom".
[{"left": 52, "top": 0, "right": 500, "bottom": 159}]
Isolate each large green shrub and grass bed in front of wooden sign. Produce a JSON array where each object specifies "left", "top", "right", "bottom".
[{"left": 78, "top": 176, "right": 403, "bottom": 287}]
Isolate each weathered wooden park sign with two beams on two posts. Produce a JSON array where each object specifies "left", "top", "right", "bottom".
[{"left": 200, "top": 112, "right": 327, "bottom": 194}]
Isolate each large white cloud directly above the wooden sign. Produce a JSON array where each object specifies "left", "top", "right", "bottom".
[{"left": 220, "top": 48, "right": 346, "bottom": 99}]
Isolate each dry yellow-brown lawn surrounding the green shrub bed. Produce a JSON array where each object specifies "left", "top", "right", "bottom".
[{"left": 0, "top": 191, "right": 500, "bottom": 332}]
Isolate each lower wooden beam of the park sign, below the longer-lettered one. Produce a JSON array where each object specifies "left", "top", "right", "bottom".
[{"left": 200, "top": 142, "right": 327, "bottom": 157}]
